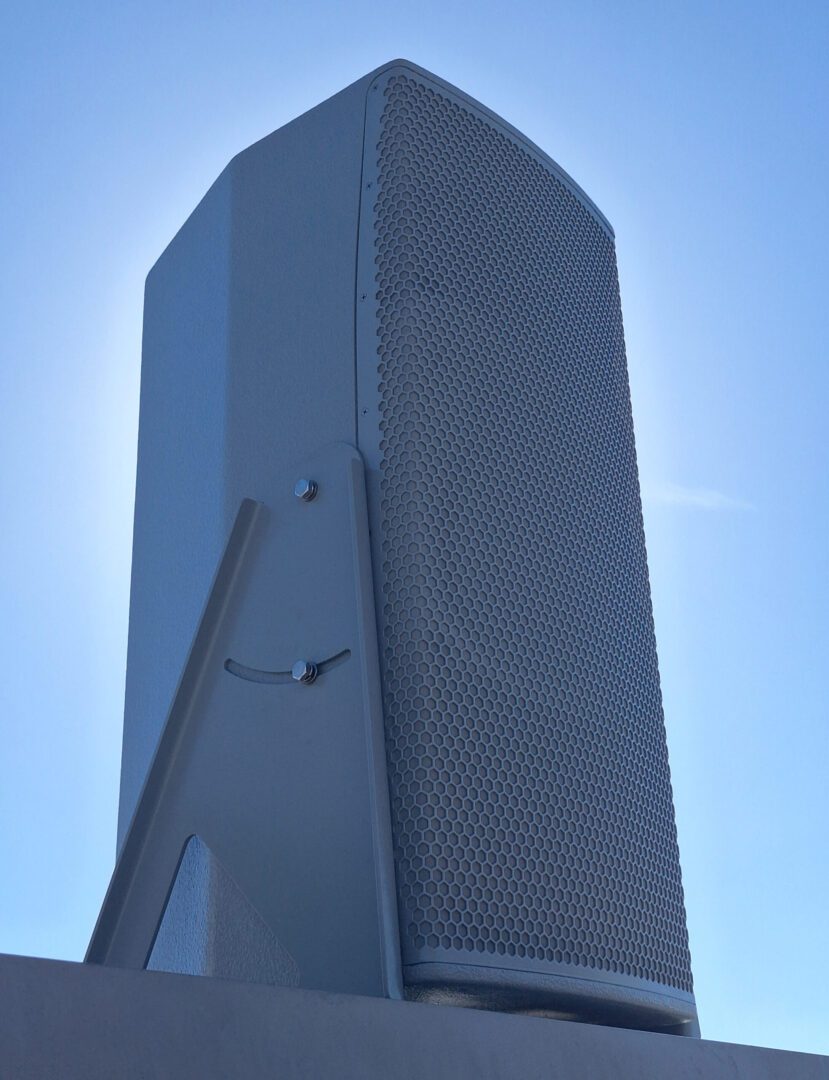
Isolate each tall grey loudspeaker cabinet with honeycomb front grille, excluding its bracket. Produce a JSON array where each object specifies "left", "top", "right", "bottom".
[{"left": 106, "top": 62, "right": 696, "bottom": 1032}]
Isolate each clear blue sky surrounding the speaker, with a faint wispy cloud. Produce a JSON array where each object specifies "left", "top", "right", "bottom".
[{"left": 0, "top": 0, "right": 829, "bottom": 1053}]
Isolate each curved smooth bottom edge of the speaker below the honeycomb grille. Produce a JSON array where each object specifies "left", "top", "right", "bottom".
[{"left": 403, "top": 961, "right": 699, "bottom": 1038}]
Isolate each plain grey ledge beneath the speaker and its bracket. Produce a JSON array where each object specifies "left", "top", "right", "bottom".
[{"left": 0, "top": 956, "right": 829, "bottom": 1080}]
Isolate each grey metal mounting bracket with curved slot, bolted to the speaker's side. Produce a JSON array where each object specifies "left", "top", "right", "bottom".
[{"left": 86, "top": 443, "right": 403, "bottom": 997}]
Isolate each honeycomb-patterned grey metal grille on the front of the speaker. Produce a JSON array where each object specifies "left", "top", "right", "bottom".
[{"left": 373, "top": 76, "right": 692, "bottom": 991}]
